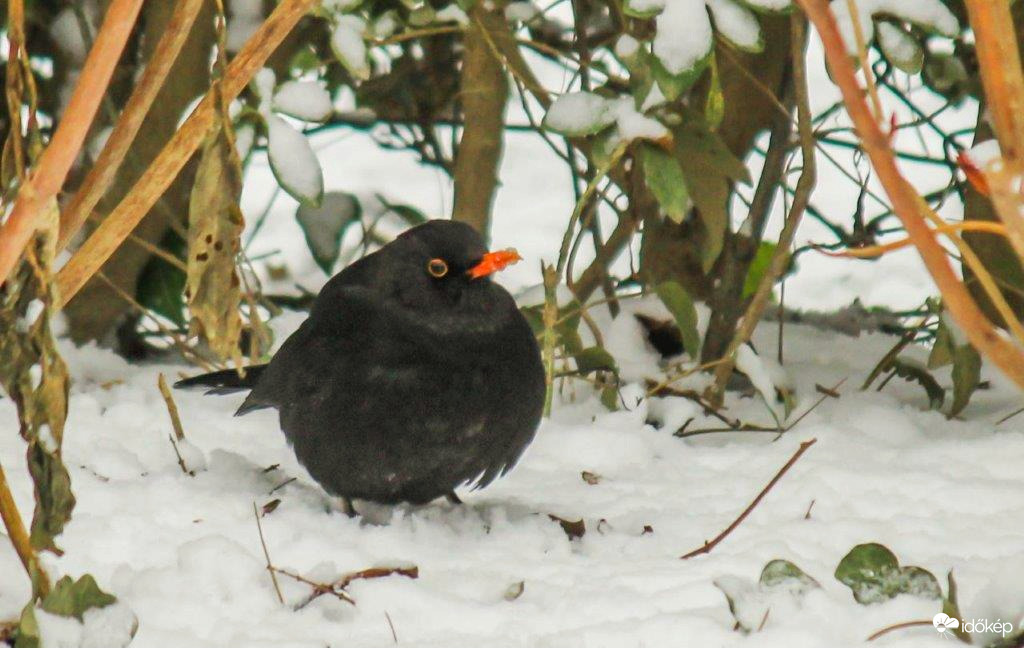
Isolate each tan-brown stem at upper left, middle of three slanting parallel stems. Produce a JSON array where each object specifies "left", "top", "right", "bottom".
[{"left": 57, "top": 0, "right": 203, "bottom": 250}]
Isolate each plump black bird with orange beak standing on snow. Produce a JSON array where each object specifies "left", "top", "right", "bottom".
[{"left": 175, "top": 220, "right": 545, "bottom": 504}]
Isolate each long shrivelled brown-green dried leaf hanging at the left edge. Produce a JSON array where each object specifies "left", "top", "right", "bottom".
[{"left": 0, "top": 202, "right": 75, "bottom": 554}]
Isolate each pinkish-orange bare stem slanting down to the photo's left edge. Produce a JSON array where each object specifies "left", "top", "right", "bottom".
[{"left": 0, "top": 0, "right": 142, "bottom": 282}]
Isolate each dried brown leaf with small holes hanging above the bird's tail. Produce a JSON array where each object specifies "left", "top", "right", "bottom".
[{"left": 185, "top": 80, "right": 244, "bottom": 364}]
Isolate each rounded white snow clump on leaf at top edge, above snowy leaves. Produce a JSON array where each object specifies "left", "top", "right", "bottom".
[{"left": 652, "top": 0, "right": 712, "bottom": 75}]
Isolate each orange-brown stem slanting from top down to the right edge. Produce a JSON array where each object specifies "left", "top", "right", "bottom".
[{"left": 798, "top": 0, "right": 1024, "bottom": 388}]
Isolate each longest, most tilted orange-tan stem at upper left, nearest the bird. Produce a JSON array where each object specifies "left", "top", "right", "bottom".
[{"left": 56, "top": 0, "right": 316, "bottom": 306}]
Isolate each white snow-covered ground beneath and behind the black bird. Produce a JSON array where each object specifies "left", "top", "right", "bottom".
[{"left": 0, "top": 26, "right": 1024, "bottom": 648}]
